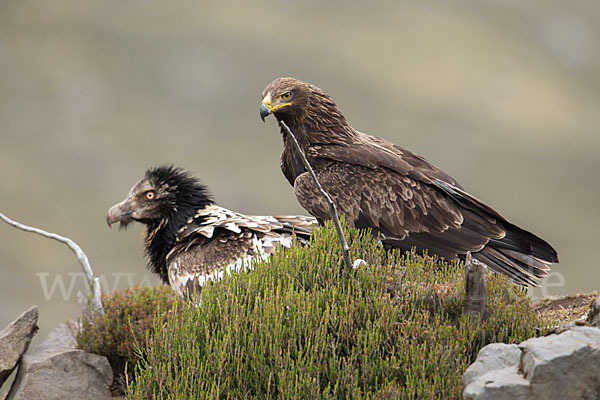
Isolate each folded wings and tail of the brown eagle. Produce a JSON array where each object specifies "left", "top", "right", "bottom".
[{"left": 294, "top": 143, "right": 558, "bottom": 286}]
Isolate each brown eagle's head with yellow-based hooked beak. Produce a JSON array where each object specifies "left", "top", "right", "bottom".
[{"left": 260, "top": 78, "right": 329, "bottom": 121}]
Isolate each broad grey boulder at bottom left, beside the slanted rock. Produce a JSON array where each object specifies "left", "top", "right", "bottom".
[{"left": 6, "top": 322, "right": 113, "bottom": 400}]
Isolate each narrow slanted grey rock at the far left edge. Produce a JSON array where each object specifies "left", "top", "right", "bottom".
[{"left": 0, "top": 306, "right": 38, "bottom": 387}]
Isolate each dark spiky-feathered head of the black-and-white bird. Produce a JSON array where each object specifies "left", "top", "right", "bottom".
[{"left": 106, "top": 166, "right": 212, "bottom": 228}]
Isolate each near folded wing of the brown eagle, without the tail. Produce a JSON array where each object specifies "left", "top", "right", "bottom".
[{"left": 294, "top": 163, "right": 494, "bottom": 258}]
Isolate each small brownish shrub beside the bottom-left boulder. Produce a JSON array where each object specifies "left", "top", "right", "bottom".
[{"left": 77, "top": 286, "right": 175, "bottom": 392}]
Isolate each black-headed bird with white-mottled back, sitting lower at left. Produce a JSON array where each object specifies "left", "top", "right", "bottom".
[{"left": 106, "top": 166, "right": 317, "bottom": 296}]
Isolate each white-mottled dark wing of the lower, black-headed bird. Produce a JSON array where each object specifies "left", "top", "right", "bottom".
[{"left": 167, "top": 205, "right": 317, "bottom": 296}]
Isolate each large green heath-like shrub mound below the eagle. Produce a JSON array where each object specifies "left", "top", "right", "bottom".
[{"left": 128, "top": 226, "right": 543, "bottom": 399}]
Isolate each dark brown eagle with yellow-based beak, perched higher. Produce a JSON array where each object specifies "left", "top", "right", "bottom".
[{"left": 260, "top": 78, "right": 558, "bottom": 286}]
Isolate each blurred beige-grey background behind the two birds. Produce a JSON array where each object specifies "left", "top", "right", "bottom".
[{"left": 0, "top": 0, "right": 600, "bottom": 354}]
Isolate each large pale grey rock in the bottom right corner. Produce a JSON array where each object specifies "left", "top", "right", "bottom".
[{"left": 463, "top": 326, "right": 600, "bottom": 400}]
